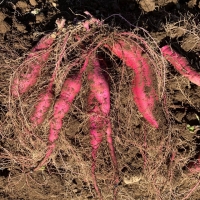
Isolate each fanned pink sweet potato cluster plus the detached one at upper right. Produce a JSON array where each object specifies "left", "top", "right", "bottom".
[{"left": 11, "top": 12, "right": 200, "bottom": 199}]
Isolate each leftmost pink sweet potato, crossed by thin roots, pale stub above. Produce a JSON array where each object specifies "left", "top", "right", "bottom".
[{"left": 11, "top": 19, "right": 65, "bottom": 97}]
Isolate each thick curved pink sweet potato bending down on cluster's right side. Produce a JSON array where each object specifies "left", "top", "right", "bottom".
[{"left": 106, "top": 40, "right": 159, "bottom": 128}]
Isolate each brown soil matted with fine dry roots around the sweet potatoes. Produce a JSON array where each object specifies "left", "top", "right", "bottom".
[{"left": 0, "top": 0, "right": 200, "bottom": 200}]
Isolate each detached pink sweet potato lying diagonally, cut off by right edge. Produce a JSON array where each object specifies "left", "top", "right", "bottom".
[{"left": 161, "top": 45, "right": 200, "bottom": 86}]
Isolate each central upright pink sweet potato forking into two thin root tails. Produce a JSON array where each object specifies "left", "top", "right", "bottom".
[{"left": 88, "top": 55, "right": 119, "bottom": 199}]
